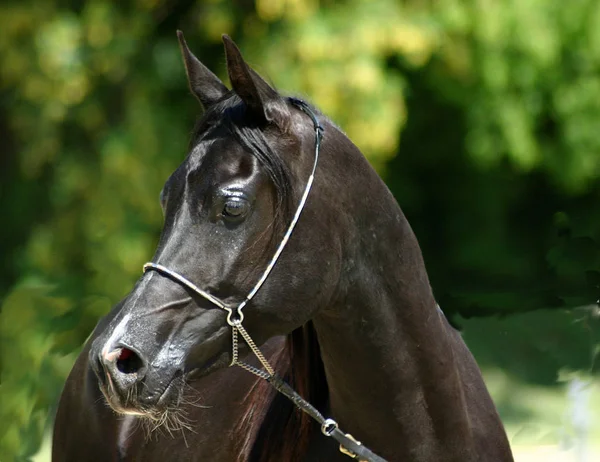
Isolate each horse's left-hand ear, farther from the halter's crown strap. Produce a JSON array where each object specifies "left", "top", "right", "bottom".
[{"left": 177, "top": 30, "right": 228, "bottom": 109}]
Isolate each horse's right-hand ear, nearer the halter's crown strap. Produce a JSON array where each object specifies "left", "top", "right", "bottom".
[{"left": 223, "top": 35, "right": 290, "bottom": 129}]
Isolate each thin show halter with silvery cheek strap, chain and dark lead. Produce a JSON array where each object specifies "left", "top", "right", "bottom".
[{"left": 144, "top": 98, "right": 386, "bottom": 462}]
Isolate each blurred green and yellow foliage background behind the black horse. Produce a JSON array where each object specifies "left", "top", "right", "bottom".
[{"left": 0, "top": 0, "right": 600, "bottom": 462}]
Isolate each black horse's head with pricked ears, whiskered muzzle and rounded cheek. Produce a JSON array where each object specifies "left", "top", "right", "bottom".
[{"left": 90, "top": 33, "right": 344, "bottom": 417}]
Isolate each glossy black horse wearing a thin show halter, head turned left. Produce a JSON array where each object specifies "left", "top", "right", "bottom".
[{"left": 53, "top": 35, "right": 513, "bottom": 462}]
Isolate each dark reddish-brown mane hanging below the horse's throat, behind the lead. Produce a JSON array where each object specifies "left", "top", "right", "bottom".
[{"left": 233, "top": 321, "right": 329, "bottom": 462}]
